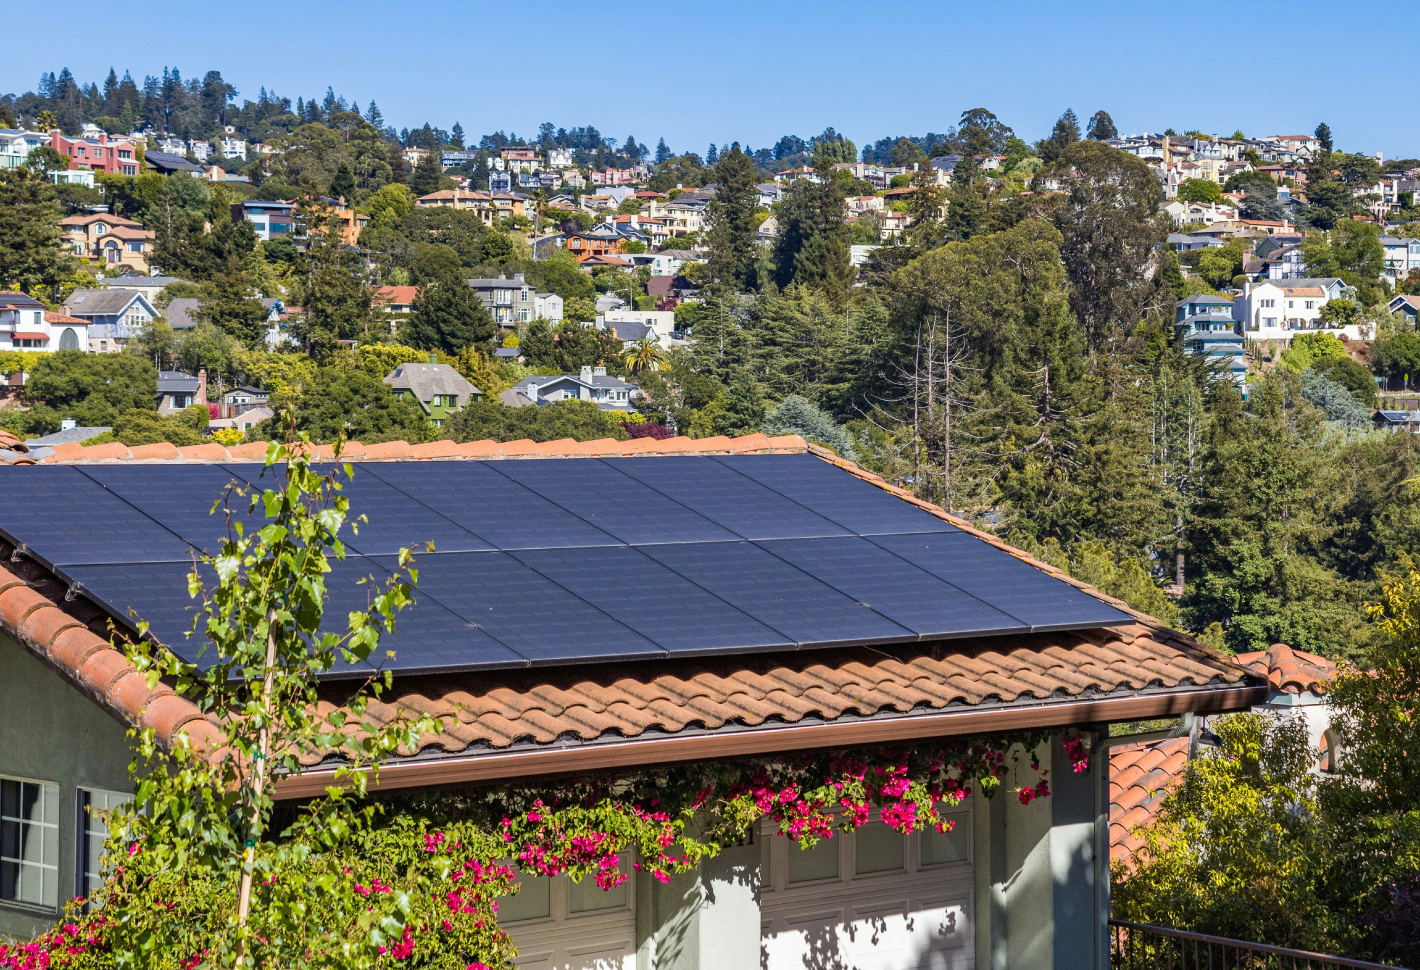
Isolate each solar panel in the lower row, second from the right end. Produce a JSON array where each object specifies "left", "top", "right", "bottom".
[{"left": 757, "top": 537, "right": 1027, "bottom": 636}]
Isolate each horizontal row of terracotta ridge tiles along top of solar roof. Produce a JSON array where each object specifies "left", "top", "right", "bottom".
[{"left": 33, "top": 432, "right": 809, "bottom": 464}]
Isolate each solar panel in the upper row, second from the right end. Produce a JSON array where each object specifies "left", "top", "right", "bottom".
[{"left": 606, "top": 457, "right": 848, "bottom": 538}]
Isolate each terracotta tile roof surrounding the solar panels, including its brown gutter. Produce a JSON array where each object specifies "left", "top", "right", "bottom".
[{"left": 0, "top": 435, "right": 1265, "bottom": 797}]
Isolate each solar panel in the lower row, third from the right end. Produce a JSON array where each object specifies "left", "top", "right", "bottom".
[{"left": 640, "top": 543, "right": 916, "bottom": 646}]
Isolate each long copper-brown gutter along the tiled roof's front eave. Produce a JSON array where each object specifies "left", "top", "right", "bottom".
[{"left": 274, "top": 685, "right": 1269, "bottom": 800}]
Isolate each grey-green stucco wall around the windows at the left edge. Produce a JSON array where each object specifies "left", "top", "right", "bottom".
[{"left": 0, "top": 635, "right": 132, "bottom": 936}]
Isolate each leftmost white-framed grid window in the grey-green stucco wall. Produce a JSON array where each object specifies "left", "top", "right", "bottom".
[{"left": 0, "top": 778, "right": 60, "bottom": 909}]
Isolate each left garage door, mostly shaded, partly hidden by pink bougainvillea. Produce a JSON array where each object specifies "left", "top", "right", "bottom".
[{"left": 498, "top": 861, "right": 636, "bottom": 970}]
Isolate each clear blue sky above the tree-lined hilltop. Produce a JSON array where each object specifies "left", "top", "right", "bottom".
[{"left": 0, "top": 0, "right": 1420, "bottom": 158}]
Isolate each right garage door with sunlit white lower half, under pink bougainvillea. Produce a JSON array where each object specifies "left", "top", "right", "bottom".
[{"left": 760, "top": 811, "right": 976, "bottom": 970}]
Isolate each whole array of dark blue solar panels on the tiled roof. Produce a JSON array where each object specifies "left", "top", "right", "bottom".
[{"left": 0, "top": 454, "right": 1130, "bottom": 673}]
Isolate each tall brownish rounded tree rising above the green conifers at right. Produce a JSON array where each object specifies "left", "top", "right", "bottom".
[{"left": 1037, "top": 142, "right": 1167, "bottom": 351}]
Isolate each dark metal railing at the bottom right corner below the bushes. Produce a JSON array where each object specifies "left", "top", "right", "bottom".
[{"left": 1109, "top": 919, "right": 1393, "bottom": 970}]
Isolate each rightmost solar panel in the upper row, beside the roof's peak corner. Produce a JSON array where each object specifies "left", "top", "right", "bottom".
[{"left": 713, "top": 454, "right": 957, "bottom": 535}]
